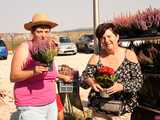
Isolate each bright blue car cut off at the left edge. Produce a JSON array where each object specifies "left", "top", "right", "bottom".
[{"left": 0, "top": 40, "right": 8, "bottom": 60}]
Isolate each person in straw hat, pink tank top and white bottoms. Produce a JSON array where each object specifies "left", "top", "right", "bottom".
[{"left": 10, "top": 13, "right": 58, "bottom": 120}]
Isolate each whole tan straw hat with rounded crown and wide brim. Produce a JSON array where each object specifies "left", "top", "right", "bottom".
[{"left": 24, "top": 13, "right": 58, "bottom": 30}]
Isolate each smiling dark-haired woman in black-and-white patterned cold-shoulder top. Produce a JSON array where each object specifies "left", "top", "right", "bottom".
[{"left": 82, "top": 23, "right": 143, "bottom": 120}]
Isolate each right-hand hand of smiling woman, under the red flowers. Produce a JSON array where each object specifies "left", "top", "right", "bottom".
[{"left": 104, "top": 82, "right": 123, "bottom": 95}]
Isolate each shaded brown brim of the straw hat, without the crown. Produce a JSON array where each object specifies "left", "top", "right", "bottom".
[{"left": 24, "top": 21, "right": 58, "bottom": 31}]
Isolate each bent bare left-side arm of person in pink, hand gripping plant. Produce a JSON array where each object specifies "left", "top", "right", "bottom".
[{"left": 10, "top": 42, "right": 48, "bottom": 82}]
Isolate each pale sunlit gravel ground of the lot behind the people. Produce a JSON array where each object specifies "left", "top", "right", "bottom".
[{"left": 0, "top": 53, "right": 91, "bottom": 120}]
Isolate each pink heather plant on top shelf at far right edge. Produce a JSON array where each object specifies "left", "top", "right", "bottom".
[{"left": 131, "top": 7, "right": 160, "bottom": 36}]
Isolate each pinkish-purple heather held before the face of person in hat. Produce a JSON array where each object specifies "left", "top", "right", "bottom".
[{"left": 30, "top": 37, "right": 57, "bottom": 70}]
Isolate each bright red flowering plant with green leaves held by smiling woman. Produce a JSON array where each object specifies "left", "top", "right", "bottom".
[{"left": 95, "top": 66, "right": 118, "bottom": 88}]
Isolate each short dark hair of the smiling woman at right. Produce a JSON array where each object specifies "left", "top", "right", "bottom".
[{"left": 95, "top": 23, "right": 119, "bottom": 40}]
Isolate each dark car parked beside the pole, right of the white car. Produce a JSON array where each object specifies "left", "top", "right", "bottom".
[{"left": 76, "top": 34, "right": 96, "bottom": 53}]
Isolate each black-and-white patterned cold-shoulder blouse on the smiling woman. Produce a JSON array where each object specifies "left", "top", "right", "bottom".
[{"left": 81, "top": 58, "right": 143, "bottom": 113}]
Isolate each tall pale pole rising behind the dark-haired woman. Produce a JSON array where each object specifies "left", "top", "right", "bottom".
[{"left": 93, "top": 0, "right": 99, "bottom": 52}]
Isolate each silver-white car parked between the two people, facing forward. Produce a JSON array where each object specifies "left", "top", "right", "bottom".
[{"left": 58, "top": 36, "right": 77, "bottom": 55}]
